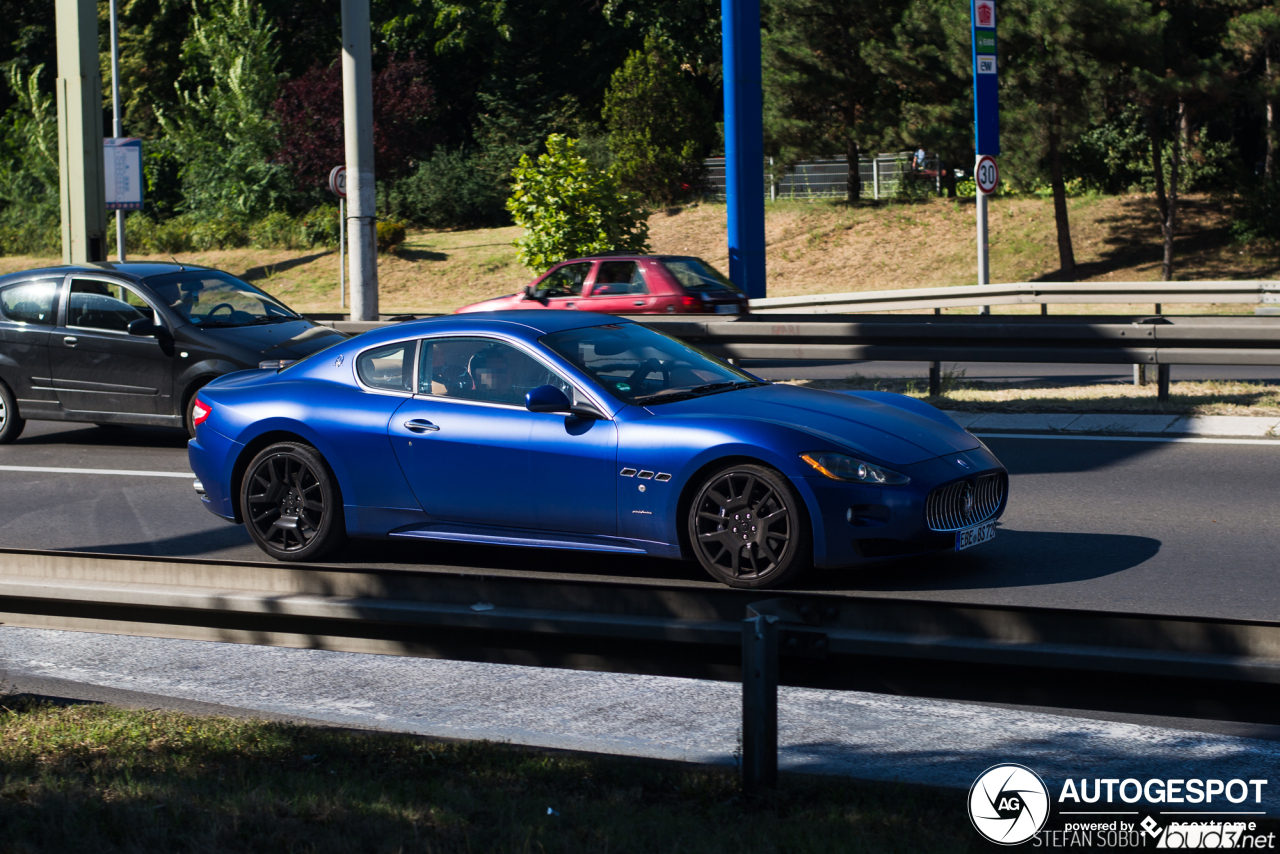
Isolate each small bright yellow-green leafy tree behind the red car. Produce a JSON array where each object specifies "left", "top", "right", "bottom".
[{"left": 507, "top": 133, "right": 649, "bottom": 270}]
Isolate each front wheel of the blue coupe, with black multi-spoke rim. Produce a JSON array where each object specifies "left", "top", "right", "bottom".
[{"left": 687, "top": 463, "right": 813, "bottom": 589}]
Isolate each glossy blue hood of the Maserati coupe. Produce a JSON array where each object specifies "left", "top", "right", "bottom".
[{"left": 649, "top": 385, "right": 979, "bottom": 466}]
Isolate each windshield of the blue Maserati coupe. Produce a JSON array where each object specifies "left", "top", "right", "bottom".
[{"left": 540, "top": 323, "right": 763, "bottom": 406}]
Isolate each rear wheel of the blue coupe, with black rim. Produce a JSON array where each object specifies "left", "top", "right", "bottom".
[{"left": 241, "top": 442, "right": 347, "bottom": 561}]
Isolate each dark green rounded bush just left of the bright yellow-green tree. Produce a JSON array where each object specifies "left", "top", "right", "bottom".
[{"left": 388, "top": 151, "right": 511, "bottom": 228}]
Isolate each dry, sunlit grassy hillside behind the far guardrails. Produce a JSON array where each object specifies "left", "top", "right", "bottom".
[{"left": 0, "top": 196, "right": 1280, "bottom": 314}]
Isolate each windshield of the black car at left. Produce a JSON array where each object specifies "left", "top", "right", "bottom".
[{"left": 146, "top": 270, "right": 300, "bottom": 329}]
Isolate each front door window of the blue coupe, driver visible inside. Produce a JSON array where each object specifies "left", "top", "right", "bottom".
[{"left": 417, "top": 338, "right": 573, "bottom": 406}]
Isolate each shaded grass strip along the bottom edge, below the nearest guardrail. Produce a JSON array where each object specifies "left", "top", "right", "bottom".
[{"left": 0, "top": 698, "right": 973, "bottom": 854}]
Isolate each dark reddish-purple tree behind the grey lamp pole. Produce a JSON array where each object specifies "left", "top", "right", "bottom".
[{"left": 273, "top": 56, "right": 435, "bottom": 188}]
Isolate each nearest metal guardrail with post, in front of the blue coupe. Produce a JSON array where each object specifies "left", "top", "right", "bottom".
[{"left": 0, "top": 549, "right": 1280, "bottom": 785}]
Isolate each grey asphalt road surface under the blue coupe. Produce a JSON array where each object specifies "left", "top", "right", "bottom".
[{"left": 0, "top": 421, "right": 1280, "bottom": 620}]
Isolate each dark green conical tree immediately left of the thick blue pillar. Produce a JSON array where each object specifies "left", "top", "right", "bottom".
[{"left": 604, "top": 38, "right": 713, "bottom": 205}]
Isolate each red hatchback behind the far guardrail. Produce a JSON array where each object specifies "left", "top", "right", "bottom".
[{"left": 454, "top": 255, "right": 750, "bottom": 314}]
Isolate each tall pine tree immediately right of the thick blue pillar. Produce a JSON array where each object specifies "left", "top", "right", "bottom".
[{"left": 763, "top": 0, "right": 901, "bottom": 201}]
